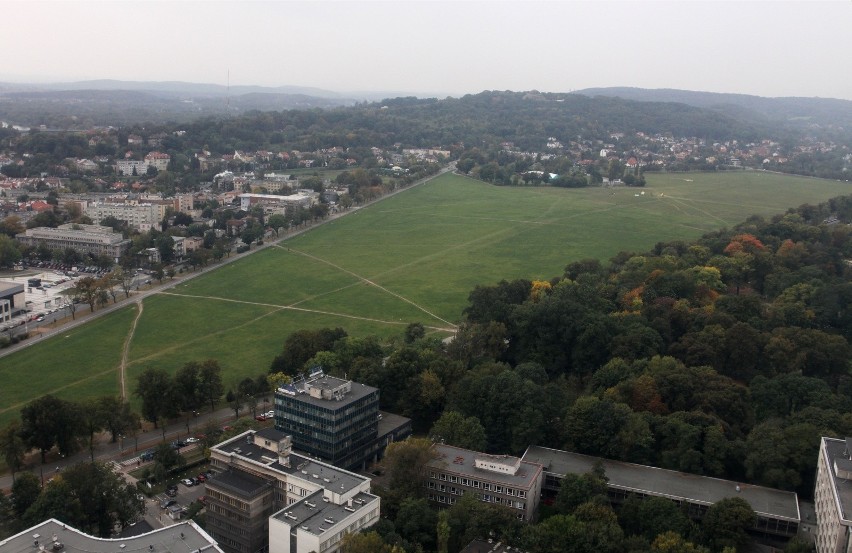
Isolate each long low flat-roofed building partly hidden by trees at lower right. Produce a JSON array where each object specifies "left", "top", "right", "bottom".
[{"left": 523, "top": 446, "right": 804, "bottom": 540}]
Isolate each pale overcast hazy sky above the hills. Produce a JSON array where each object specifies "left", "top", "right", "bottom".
[{"left": 6, "top": 0, "right": 852, "bottom": 100}]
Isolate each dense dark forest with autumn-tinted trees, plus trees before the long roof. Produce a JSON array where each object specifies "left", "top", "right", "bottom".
[{"left": 260, "top": 197, "right": 852, "bottom": 551}]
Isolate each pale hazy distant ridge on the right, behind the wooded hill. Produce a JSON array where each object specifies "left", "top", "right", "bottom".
[{"left": 574, "top": 87, "right": 852, "bottom": 131}]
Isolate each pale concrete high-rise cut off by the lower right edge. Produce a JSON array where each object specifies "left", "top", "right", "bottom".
[{"left": 814, "top": 438, "right": 852, "bottom": 553}]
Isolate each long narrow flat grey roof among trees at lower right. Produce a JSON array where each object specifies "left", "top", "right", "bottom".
[{"left": 523, "top": 442, "right": 804, "bottom": 522}]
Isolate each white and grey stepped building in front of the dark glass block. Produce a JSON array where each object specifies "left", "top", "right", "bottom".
[{"left": 206, "top": 428, "right": 381, "bottom": 553}]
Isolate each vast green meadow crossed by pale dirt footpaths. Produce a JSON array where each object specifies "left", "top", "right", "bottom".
[{"left": 0, "top": 172, "right": 849, "bottom": 423}]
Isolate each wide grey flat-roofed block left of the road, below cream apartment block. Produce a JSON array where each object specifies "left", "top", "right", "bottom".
[{"left": 15, "top": 223, "right": 130, "bottom": 262}]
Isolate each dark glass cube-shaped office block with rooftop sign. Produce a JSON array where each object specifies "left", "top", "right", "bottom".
[{"left": 275, "top": 370, "right": 411, "bottom": 469}]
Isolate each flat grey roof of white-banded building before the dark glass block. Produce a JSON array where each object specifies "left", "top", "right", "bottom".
[{"left": 213, "top": 429, "right": 367, "bottom": 493}]
